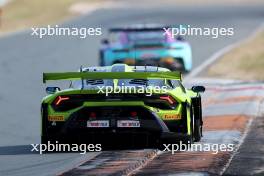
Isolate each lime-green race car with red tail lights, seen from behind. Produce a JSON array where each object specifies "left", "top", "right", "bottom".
[{"left": 41, "top": 64, "right": 205, "bottom": 147}]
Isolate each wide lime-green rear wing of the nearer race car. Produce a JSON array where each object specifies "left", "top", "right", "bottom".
[{"left": 43, "top": 72, "right": 182, "bottom": 83}]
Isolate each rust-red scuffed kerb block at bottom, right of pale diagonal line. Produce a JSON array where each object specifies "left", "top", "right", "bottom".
[{"left": 135, "top": 152, "right": 230, "bottom": 176}]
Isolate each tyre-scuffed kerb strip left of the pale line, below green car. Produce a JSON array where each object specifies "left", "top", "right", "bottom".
[{"left": 61, "top": 149, "right": 158, "bottom": 176}]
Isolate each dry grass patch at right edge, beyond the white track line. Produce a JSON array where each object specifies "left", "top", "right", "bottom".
[{"left": 206, "top": 31, "right": 264, "bottom": 81}]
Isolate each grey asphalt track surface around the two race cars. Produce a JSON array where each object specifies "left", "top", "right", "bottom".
[{"left": 0, "top": 1, "right": 264, "bottom": 175}]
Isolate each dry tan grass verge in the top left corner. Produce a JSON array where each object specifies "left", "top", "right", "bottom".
[{"left": 0, "top": 0, "right": 96, "bottom": 33}]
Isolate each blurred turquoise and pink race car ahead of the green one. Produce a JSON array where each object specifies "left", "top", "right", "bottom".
[{"left": 99, "top": 24, "right": 192, "bottom": 72}]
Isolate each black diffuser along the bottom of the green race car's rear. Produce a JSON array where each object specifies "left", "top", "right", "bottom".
[{"left": 42, "top": 131, "right": 190, "bottom": 150}]
